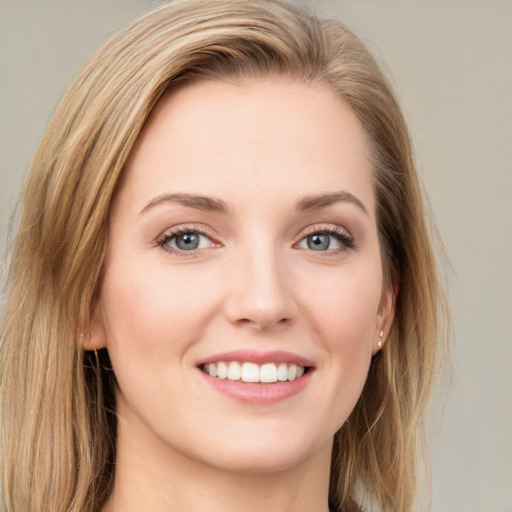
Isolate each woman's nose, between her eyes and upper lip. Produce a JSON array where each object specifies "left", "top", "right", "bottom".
[{"left": 225, "top": 242, "right": 297, "bottom": 331}]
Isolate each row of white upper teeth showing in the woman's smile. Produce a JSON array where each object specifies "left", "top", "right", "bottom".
[{"left": 200, "top": 361, "right": 309, "bottom": 384}]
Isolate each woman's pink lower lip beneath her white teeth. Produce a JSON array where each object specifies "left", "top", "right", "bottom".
[{"left": 198, "top": 368, "right": 313, "bottom": 404}]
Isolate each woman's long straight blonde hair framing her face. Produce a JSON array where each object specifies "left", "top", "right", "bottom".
[{"left": 0, "top": 0, "right": 444, "bottom": 512}]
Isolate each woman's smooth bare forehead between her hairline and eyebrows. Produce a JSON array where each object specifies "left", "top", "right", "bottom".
[{"left": 121, "top": 78, "right": 374, "bottom": 216}]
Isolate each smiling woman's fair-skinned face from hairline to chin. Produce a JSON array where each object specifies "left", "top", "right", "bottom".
[{"left": 91, "top": 78, "right": 392, "bottom": 471}]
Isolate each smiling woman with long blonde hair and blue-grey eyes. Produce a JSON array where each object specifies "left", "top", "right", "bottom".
[{"left": 1, "top": 0, "right": 443, "bottom": 512}]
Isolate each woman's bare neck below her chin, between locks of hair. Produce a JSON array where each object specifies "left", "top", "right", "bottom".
[{"left": 102, "top": 400, "right": 331, "bottom": 512}]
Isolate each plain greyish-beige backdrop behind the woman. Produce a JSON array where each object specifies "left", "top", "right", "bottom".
[{"left": 0, "top": 0, "right": 512, "bottom": 512}]
